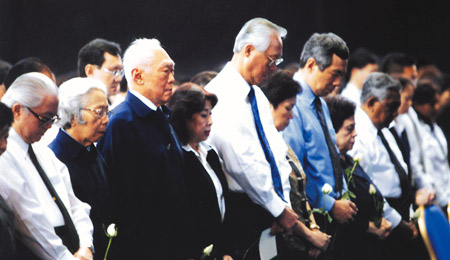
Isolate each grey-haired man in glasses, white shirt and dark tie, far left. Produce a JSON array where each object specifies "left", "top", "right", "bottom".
[{"left": 0, "top": 72, "right": 93, "bottom": 259}]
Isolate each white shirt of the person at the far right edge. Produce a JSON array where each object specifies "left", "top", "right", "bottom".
[{"left": 419, "top": 121, "right": 450, "bottom": 207}]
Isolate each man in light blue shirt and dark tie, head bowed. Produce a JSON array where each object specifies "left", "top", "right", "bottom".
[{"left": 283, "top": 33, "right": 357, "bottom": 244}]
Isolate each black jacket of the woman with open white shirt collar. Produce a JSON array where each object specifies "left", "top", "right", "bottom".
[{"left": 183, "top": 149, "right": 228, "bottom": 259}]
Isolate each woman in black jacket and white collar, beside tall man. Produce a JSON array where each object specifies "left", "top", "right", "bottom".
[{"left": 169, "top": 83, "right": 230, "bottom": 259}]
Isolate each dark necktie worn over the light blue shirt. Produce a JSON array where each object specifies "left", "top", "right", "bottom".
[{"left": 314, "top": 97, "right": 343, "bottom": 196}]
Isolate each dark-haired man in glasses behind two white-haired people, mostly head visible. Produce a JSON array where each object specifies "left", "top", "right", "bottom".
[{"left": 78, "top": 38, "right": 124, "bottom": 107}]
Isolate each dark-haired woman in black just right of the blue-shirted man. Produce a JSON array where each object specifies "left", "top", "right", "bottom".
[{"left": 326, "top": 96, "right": 392, "bottom": 259}]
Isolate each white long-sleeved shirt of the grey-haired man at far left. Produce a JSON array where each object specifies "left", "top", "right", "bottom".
[{"left": 0, "top": 128, "right": 93, "bottom": 260}]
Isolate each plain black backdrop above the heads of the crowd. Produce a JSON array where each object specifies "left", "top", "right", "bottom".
[{"left": 0, "top": 0, "right": 450, "bottom": 81}]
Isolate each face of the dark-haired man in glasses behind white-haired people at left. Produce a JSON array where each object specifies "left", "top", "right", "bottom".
[{"left": 92, "top": 52, "right": 123, "bottom": 97}]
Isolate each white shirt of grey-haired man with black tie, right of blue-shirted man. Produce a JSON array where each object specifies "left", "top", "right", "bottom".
[{"left": 349, "top": 107, "right": 408, "bottom": 227}]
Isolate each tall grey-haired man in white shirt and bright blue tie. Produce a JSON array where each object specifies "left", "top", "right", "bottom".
[{"left": 206, "top": 18, "right": 298, "bottom": 257}]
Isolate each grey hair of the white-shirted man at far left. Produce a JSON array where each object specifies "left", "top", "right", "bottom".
[{"left": 2, "top": 72, "right": 58, "bottom": 109}]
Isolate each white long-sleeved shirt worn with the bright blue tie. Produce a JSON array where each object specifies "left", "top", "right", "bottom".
[{"left": 206, "top": 62, "right": 292, "bottom": 217}]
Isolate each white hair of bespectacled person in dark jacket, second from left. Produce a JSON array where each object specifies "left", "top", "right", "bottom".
[{"left": 58, "top": 77, "right": 106, "bottom": 129}]
